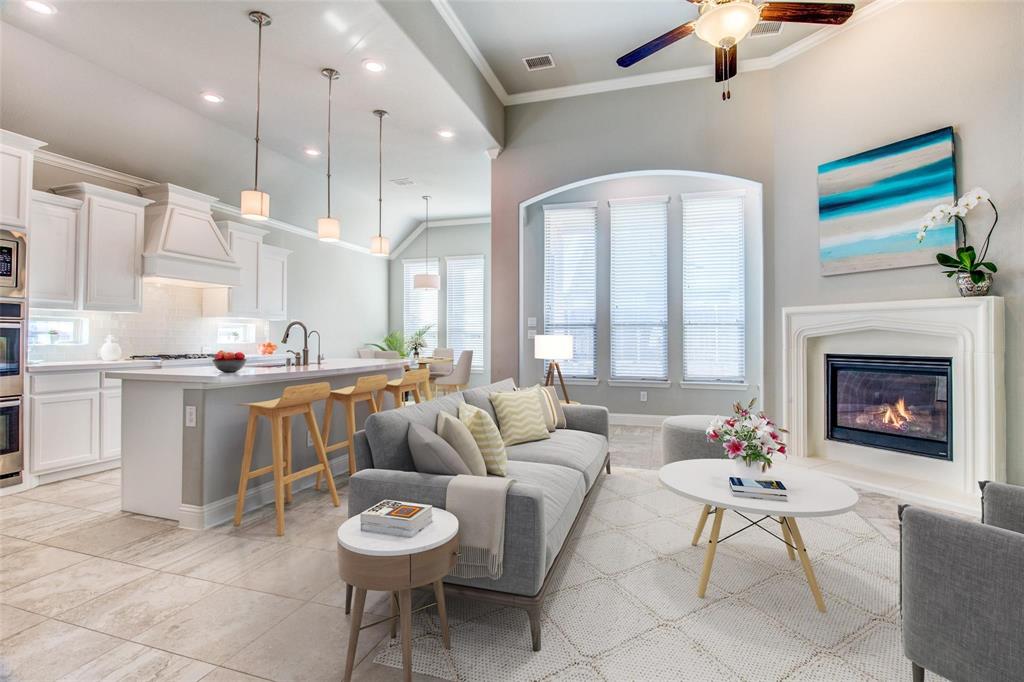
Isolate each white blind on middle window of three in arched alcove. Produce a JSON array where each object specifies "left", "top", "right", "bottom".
[{"left": 609, "top": 197, "right": 669, "bottom": 381}]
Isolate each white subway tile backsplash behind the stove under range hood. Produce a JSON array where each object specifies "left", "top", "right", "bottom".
[{"left": 29, "top": 282, "right": 269, "bottom": 361}]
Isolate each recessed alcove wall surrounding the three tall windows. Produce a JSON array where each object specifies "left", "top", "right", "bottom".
[{"left": 519, "top": 175, "right": 764, "bottom": 415}]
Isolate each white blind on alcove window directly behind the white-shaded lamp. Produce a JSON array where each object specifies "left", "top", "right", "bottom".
[{"left": 544, "top": 203, "right": 597, "bottom": 379}]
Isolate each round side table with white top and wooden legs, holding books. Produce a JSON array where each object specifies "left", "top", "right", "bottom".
[{"left": 338, "top": 508, "right": 459, "bottom": 682}]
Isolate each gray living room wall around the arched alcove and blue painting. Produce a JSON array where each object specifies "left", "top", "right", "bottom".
[{"left": 492, "top": 2, "right": 1024, "bottom": 483}]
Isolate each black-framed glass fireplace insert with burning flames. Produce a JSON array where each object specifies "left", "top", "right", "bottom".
[{"left": 825, "top": 354, "right": 953, "bottom": 461}]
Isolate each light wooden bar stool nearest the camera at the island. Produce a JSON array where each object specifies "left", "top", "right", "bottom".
[{"left": 234, "top": 382, "right": 341, "bottom": 536}]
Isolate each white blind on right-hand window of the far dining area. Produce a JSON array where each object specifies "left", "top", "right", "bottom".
[{"left": 444, "top": 256, "right": 484, "bottom": 371}]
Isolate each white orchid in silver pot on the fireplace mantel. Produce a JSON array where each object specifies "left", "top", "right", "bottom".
[{"left": 918, "top": 187, "right": 999, "bottom": 296}]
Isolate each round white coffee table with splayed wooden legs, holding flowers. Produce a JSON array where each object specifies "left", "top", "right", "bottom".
[{"left": 658, "top": 460, "right": 857, "bottom": 611}]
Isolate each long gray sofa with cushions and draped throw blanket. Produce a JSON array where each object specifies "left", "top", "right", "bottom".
[{"left": 348, "top": 379, "right": 611, "bottom": 650}]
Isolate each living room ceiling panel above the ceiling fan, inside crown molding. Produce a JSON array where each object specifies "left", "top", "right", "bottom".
[{"left": 444, "top": 0, "right": 872, "bottom": 95}]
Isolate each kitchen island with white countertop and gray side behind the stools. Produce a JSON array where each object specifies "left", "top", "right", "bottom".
[{"left": 106, "top": 358, "right": 406, "bottom": 528}]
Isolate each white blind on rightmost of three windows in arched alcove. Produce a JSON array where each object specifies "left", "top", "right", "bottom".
[{"left": 682, "top": 191, "right": 746, "bottom": 383}]
